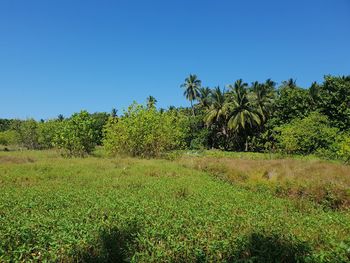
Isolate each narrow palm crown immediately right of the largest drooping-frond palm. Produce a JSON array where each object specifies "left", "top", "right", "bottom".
[{"left": 251, "top": 79, "right": 276, "bottom": 123}]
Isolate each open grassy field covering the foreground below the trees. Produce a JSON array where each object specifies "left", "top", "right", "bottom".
[{"left": 0, "top": 151, "right": 350, "bottom": 262}]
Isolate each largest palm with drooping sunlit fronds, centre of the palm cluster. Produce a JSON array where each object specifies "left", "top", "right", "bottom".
[{"left": 225, "top": 79, "right": 260, "bottom": 151}]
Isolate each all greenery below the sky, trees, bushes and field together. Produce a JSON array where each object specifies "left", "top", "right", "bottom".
[{"left": 0, "top": 75, "right": 350, "bottom": 262}]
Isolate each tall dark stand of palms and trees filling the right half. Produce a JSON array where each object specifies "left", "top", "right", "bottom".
[{"left": 182, "top": 75, "right": 350, "bottom": 161}]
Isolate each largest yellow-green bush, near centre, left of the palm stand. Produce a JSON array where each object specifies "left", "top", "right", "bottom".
[{"left": 103, "top": 103, "right": 187, "bottom": 157}]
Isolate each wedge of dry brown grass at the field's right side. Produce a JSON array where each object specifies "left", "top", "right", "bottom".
[{"left": 179, "top": 157, "right": 350, "bottom": 209}]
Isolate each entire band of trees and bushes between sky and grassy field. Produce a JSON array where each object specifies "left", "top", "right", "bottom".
[{"left": 0, "top": 75, "right": 350, "bottom": 160}]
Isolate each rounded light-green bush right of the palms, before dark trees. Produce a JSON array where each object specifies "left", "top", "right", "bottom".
[{"left": 275, "top": 112, "right": 339, "bottom": 154}]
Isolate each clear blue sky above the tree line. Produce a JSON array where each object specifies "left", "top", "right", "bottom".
[{"left": 0, "top": 0, "right": 350, "bottom": 119}]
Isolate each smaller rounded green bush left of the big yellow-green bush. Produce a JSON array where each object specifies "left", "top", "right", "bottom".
[{"left": 54, "top": 111, "right": 96, "bottom": 157}]
